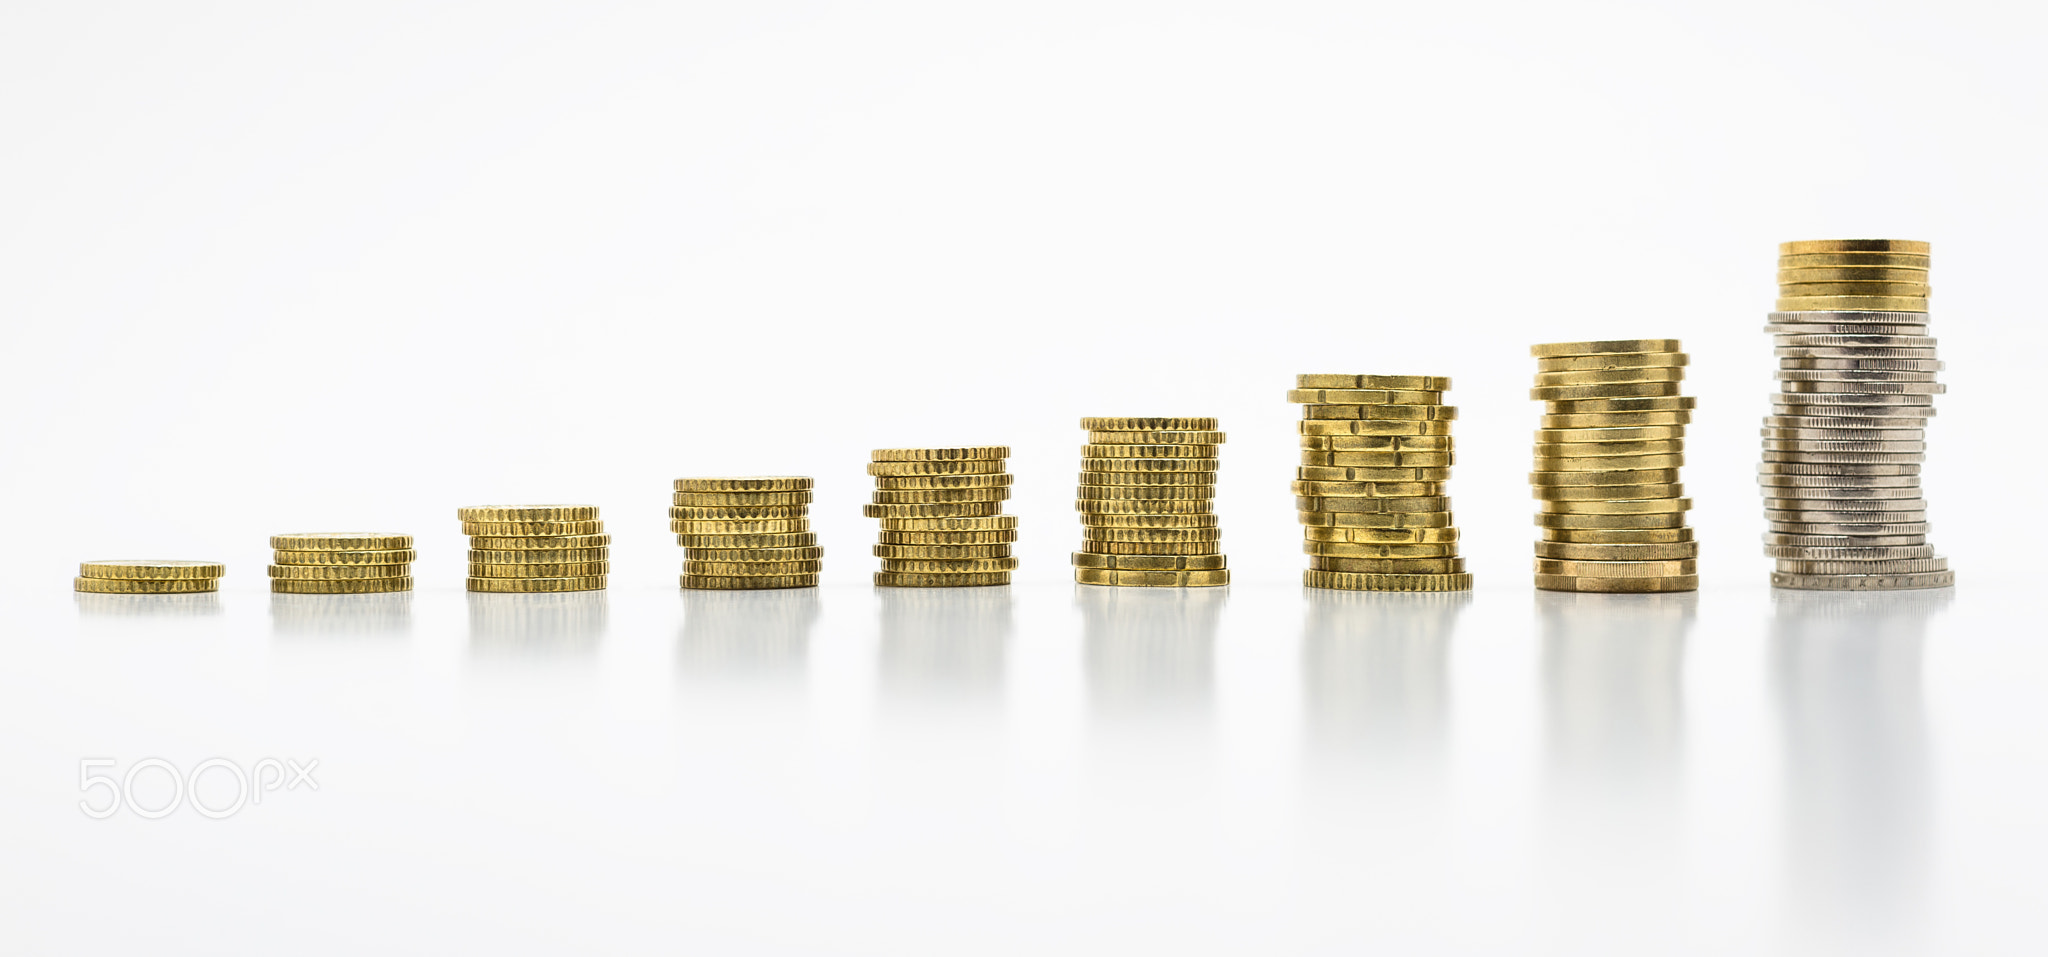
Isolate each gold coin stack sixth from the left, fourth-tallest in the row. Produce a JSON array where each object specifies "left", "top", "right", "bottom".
[{"left": 1073, "top": 418, "right": 1231, "bottom": 588}]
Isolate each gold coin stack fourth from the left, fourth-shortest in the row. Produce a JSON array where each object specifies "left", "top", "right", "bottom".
[{"left": 668, "top": 475, "right": 825, "bottom": 590}]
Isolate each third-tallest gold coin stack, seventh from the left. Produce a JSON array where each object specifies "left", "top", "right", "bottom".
[{"left": 1286, "top": 375, "right": 1473, "bottom": 592}]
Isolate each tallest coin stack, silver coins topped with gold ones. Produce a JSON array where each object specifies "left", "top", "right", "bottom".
[{"left": 1757, "top": 240, "right": 1956, "bottom": 590}]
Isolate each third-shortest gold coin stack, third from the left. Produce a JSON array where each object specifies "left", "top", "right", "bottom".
[{"left": 455, "top": 504, "right": 612, "bottom": 592}]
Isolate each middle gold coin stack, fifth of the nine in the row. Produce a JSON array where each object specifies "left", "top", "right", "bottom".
[{"left": 866, "top": 445, "right": 1018, "bottom": 588}]
